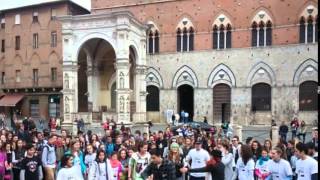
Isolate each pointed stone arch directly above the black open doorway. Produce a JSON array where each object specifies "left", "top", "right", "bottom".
[{"left": 172, "top": 65, "right": 198, "bottom": 88}]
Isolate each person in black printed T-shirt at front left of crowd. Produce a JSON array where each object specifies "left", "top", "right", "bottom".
[{"left": 20, "top": 144, "right": 43, "bottom": 180}]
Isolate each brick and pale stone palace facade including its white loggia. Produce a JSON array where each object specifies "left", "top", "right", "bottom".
[{"left": 61, "top": 0, "right": 318, "bottom": 129}]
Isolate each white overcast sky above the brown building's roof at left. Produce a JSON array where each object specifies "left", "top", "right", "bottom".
[{"left": 0, "top": 0, "right": 91, "bottom": 10}]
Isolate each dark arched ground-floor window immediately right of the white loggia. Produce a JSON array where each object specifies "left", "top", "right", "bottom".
[{"left": 147, "top": 85, "right": 159, "bottom": 111}]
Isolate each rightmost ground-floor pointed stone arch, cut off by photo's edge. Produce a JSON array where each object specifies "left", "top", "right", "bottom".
[{"left": 293, "top": 59, "right": 318, "bottom": 86}]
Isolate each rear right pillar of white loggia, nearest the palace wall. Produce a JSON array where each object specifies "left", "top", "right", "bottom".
[{"left": 133, "top": 65, "right": 147, "bottom": 123}]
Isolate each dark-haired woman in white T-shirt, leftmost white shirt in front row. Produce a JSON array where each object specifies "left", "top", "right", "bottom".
[{"left": 57, "top": 154, "right": 83, "bottom": 180}]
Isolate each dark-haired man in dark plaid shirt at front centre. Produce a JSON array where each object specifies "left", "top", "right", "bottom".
[{"left": 141, "top": 149, "right": 176, "bottom": 180}]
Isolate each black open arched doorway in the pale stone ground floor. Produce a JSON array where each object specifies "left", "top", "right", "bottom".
[{"left": 178, "top": 84, "right": 193, "bottom": 119}]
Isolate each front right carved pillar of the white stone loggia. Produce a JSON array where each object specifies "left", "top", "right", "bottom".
[{"left": 115, "top": 58, "right": 131, "bottom": 124}]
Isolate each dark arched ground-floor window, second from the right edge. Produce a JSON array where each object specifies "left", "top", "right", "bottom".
[{"left": 251, "top": 83, "right": 271, "bottom": 112}]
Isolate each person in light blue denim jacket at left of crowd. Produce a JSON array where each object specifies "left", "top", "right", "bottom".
[{"left": 41, "top": 134, "right": 57, "bottom": 180}]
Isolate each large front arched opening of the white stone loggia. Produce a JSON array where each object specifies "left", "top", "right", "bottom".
[{"left": 78, "top": 38, "right": 116, "bottom": 112}]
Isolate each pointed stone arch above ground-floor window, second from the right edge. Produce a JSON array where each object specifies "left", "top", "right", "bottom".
[{"left": 247, "top": 61, "right": 276, "bottom": 87}]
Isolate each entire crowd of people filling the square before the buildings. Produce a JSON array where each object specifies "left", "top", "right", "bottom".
[{"left": 0, "top": 114, "right": 318, "bottom": 180}]
